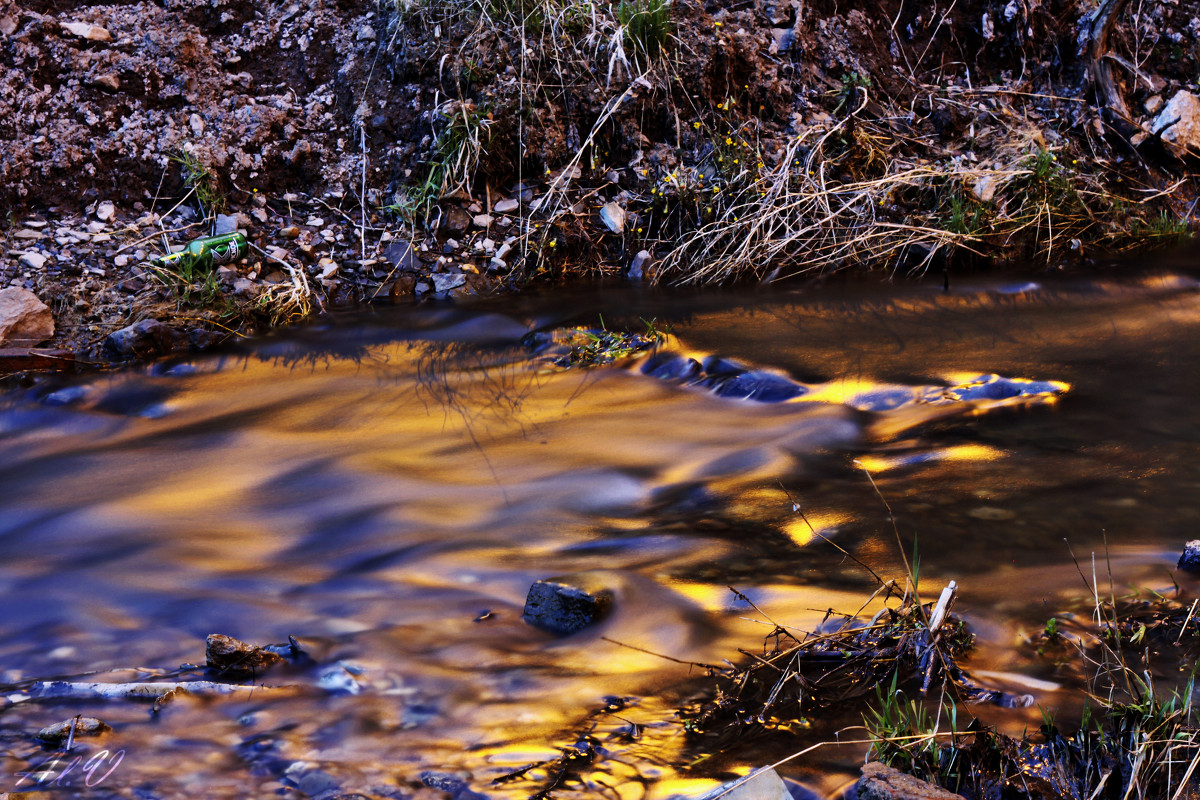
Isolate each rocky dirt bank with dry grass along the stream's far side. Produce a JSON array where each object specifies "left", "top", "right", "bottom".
[{"left": 0, "top": 0, "right": 1200, "bottom": 354}]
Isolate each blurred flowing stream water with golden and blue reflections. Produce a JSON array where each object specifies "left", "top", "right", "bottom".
[{"left": 0, "top": 275, "right": 1200, "bottom": 798}]
